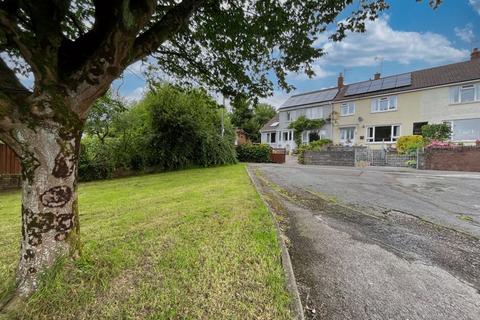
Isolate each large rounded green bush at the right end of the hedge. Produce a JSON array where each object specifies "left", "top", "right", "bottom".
[{"left": 141, "top": 84, "right": 236, "bottom": 170}]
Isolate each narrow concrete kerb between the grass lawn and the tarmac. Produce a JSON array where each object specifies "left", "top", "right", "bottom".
[{"left": 246, "top": 165, "right": 305, "bottom": 320}]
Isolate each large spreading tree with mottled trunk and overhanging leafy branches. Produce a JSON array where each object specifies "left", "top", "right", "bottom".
[{"left": 0, "top": 0, "right": 438, "bottom": 296}]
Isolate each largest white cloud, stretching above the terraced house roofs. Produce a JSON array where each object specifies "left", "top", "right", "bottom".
[{"left": 320, "top": 16, "right": 469, "bottom": 67}]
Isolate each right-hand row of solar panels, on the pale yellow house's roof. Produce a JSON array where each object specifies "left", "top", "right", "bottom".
[{"left": 345, "top": 73, "right": 412, "bottom": 96}]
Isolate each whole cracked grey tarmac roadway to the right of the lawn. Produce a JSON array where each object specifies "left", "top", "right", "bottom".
[{"left": 251, "top": 165, "right": 480, "bottom": 320}]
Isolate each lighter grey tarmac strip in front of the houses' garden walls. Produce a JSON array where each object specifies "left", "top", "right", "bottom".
[{"left": 262, "top": 160, "right": 480, "bottom": 238}]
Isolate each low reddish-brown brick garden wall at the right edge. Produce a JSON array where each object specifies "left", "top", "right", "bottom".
[{"left": 422, "top": 147, "right": 480, "bottom": 172}]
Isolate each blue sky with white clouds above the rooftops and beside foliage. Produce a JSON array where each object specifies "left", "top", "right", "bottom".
[{"left": 114, "top": 0, "right": 480, "bottom": 107}]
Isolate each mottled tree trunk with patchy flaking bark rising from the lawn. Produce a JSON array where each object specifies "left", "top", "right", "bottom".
[{"left": 16, "top": 120, "right": 81, "bottom": 297}]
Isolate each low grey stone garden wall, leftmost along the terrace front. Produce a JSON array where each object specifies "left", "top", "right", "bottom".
[{"left": 304, "top": 149, "right": 355, "bottom": 167}]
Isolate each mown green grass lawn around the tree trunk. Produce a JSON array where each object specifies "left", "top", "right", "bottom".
[{"left": 0, "top": 165, "right": 291, "bottom": 319}]
